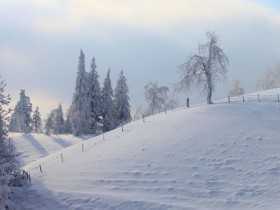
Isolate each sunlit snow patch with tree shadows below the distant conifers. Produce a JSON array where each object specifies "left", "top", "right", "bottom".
[{"left": 9, "top": 133, "right": 90, "bottom": 166}]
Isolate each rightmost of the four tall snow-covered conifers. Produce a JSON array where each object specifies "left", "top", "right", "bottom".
[{"left": 114, "top": 71, "right": 131, "bottom": 125}]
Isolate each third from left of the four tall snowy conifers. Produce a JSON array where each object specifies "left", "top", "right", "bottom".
[{"left": 101, "top": 69, "right": 116, "bottom": 132}]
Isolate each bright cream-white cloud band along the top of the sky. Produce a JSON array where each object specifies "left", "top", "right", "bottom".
[{"left": 25, "top": 0, "right": 280, "bottom": 34}]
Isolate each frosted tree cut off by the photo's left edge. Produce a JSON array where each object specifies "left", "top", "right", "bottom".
[{"left": 0, "top": 76, "right": 23, "bottom": 209}]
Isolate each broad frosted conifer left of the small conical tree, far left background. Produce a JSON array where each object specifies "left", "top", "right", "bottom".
[{"left": 10, "top": 90, "right": 32, "bottom": 133}]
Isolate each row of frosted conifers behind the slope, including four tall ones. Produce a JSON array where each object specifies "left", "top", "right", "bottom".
[{"left": 9, "top": 50, "right": 131, "bottom": 136}]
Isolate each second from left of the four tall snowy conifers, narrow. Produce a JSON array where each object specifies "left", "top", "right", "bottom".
[{"left": 88, "top": 57, "right": 103, "bottom": 132}]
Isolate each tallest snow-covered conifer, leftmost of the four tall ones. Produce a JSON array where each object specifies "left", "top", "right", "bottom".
[{"left": 69, "top": 50, "right": 93, "bottom": 136}]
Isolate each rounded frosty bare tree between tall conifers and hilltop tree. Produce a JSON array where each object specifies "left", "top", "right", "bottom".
[{"left": 144, "top": 82, "right": 169, "bottom": 114}]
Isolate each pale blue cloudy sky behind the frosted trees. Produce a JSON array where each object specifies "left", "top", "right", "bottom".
[{"left": 0, "top": 0, "right": 280, "bottom": 118}]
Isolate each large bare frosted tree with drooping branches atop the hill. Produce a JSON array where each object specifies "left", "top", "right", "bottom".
[{"left": 176, "top": 32, "right": 228, "bottom": 104}]
